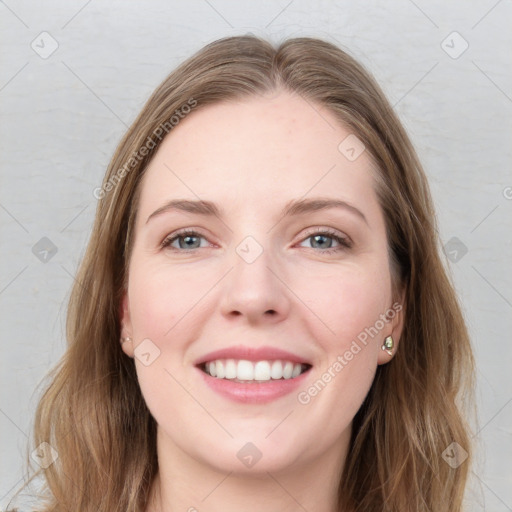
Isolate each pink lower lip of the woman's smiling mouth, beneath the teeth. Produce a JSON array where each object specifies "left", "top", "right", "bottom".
[{"left": 197, "top": 368, "right": 311, "bottom": 404}]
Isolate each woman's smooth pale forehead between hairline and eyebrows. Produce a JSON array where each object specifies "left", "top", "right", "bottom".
[{"left": 136, "top": 92, "right": 376, "bottom": 216}]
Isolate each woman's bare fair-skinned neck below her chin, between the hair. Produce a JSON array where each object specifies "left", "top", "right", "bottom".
[{"left": 146, "top": 429, "right": 350, "bottom": 512}]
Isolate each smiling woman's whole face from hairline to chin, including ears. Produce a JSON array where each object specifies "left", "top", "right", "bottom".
[{"left": 122, "top": 92, "right": 402, "bottom": 472}]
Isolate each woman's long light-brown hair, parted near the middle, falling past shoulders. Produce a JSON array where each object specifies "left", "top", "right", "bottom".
[{"left": 16, "top": 36, "right": 474, "bottom": 512}]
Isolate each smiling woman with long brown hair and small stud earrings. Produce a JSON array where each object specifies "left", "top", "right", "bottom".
[{"left": 19, "top": 37, "right": 473, "bottom": 512}]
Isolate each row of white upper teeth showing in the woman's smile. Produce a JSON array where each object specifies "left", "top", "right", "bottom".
[{"left": 204, "top": 359, "right": 303, "bottom": 382}]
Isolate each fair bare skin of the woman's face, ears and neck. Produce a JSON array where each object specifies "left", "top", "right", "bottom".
[{"left": 121, "top": 91, "right": 403, "bottom": 512}]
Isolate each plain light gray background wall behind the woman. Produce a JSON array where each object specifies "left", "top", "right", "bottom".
[{"left": 0, "top": 0, "right": 512, "bottom": 511}]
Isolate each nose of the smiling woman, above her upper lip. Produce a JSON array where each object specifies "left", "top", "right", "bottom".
[{"left": 220, "top": 251, "right": 290, "bottom": 325}]
